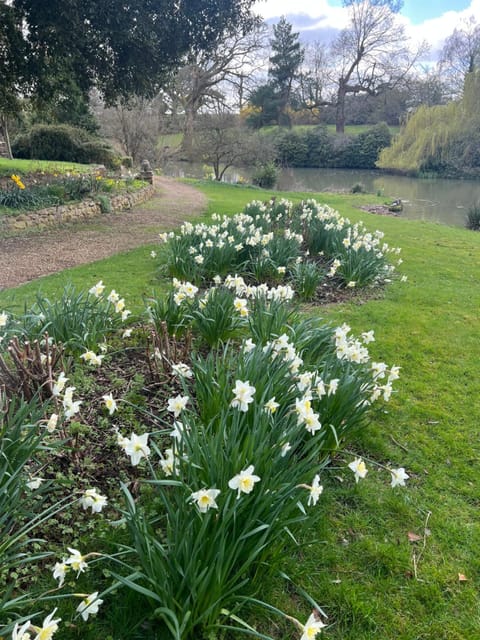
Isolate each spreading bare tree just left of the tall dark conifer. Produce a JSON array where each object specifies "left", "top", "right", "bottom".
[{"left": 165, "top": 24, "right": 266, "bottom": 155}]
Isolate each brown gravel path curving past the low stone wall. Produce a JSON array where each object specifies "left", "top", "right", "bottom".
[{"left": 0, "top": 177, "right": 207, "bottom": 290}]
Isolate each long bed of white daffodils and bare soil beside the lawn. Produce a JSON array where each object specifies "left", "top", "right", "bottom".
[{"left": 0, "top": 204, "right": 408, "bottom": 640}]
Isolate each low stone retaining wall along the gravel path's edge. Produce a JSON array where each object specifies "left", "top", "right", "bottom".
[{"left": 0, "top": 185, "right": 155, "bottom": 231}]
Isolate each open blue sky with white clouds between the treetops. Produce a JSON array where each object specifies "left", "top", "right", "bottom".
[{"left": 254, "top": 0, "right": 480, "bottom": 60}]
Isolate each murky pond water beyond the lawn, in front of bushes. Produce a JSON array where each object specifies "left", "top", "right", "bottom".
[{"left": 164, "top": 163, "right": 480, "bottom": 227}]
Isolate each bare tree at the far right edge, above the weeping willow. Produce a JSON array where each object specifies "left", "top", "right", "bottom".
[{"left": 439, "top": 16, "right": 480, "bottom": 95}]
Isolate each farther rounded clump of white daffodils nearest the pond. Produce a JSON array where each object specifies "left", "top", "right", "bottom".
[{"left": 162, "top": 200, "right": 401, "bottom": 295}]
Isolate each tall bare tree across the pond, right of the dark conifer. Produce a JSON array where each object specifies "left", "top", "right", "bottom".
[{"left": 322, "top": 0, "right": 426, "bottom": 133}]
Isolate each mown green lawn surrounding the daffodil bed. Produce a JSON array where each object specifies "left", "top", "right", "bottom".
[{"left": 0, "top": 183, "right": 480, "bottom": 640}]
